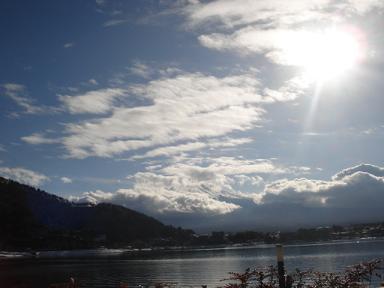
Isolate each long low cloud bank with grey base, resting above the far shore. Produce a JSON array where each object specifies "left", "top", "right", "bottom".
[{"left": 72, "top": 163, "right": 384, "bottom": 229}]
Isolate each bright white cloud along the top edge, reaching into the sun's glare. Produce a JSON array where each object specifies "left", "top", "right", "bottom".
[{"left": 182, "top": 0, "right": 384, "bottom": 65}]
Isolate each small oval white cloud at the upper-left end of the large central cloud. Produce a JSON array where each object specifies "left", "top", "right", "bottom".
[{"left": 59, "top": 88, "right": 126, "bottom": 114}]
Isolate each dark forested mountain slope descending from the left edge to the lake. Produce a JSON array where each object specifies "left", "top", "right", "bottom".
[{"left": 0, "top": 177, "right": 193, "bottom": 250}]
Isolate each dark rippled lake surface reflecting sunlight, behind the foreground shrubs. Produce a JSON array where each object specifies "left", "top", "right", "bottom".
[{"left": 0, "top": 240, "right": 384, "bottom": 288}]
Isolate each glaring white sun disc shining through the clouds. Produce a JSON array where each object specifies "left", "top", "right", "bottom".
[{"left": 285, "top": 28, "right": 363, "bottom": 82}]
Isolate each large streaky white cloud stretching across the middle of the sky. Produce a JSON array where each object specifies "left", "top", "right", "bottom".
[{"left": 62, "top": 73, "right": 264, "bottom": 158}]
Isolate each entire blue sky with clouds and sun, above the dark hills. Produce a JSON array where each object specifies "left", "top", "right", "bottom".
[{"left": 0, "top": 0, "right": 384, "bottom": 231}]
